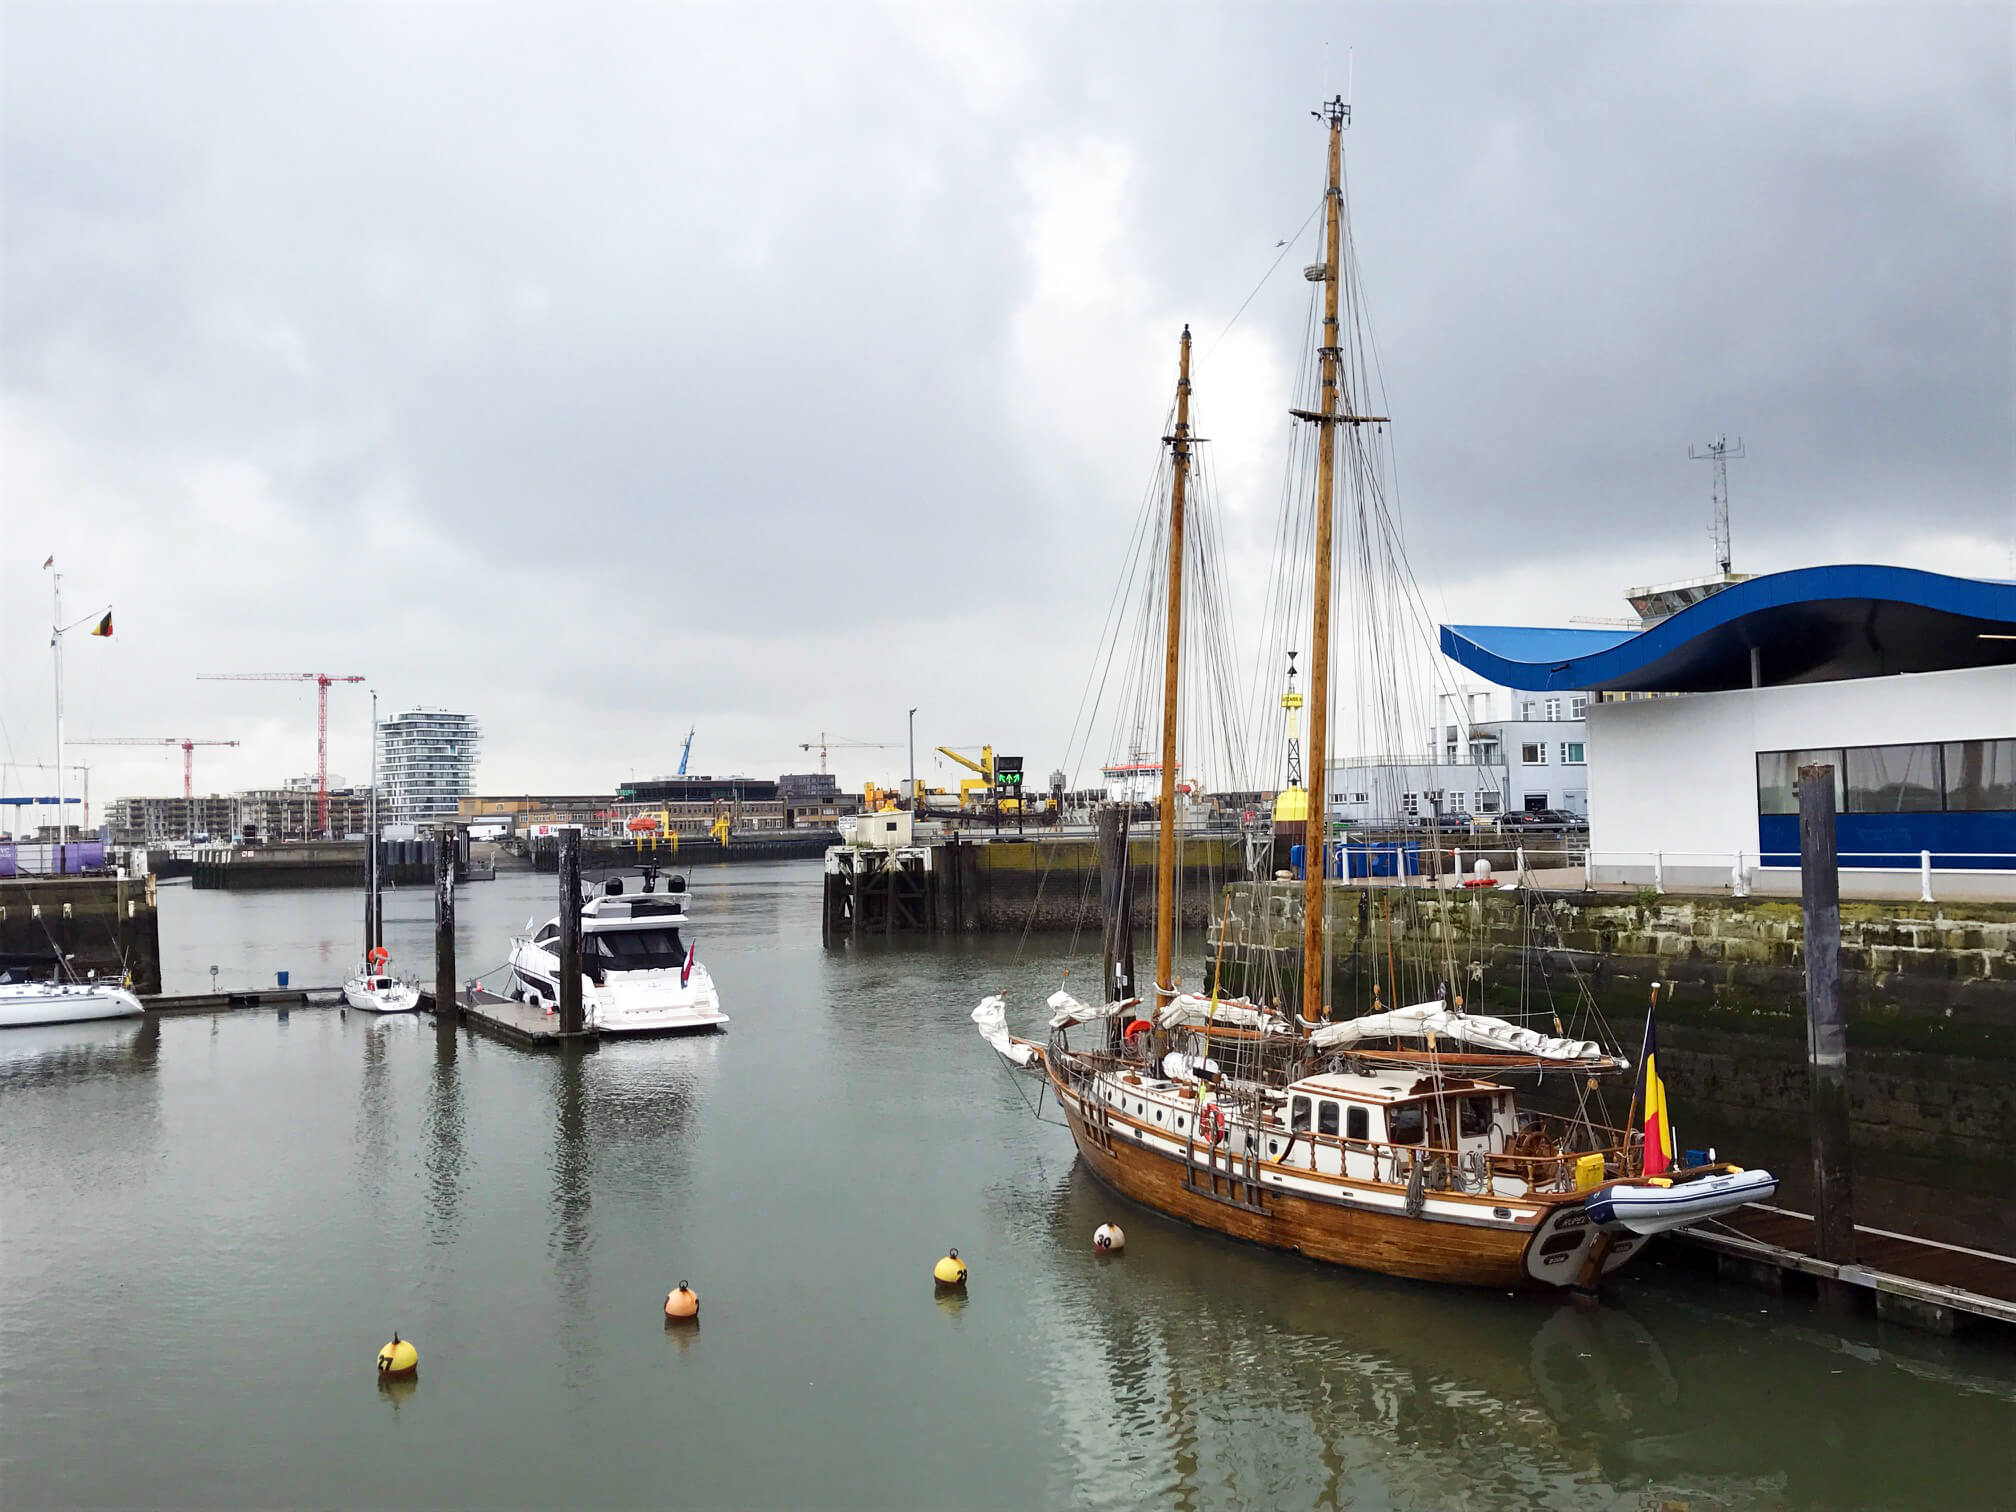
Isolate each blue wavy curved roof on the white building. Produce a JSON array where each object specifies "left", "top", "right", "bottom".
[{"left": 1441, "top": 564, "right": 2016, "bottom": 694}]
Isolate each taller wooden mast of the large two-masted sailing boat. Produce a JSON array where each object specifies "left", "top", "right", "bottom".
[{"left": 1302, "top": 97, "right": 1351, "bottom": 1020}]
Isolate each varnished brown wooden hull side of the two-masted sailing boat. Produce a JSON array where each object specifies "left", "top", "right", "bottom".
[{"left": 1064, "top": 1103, "right": 1540, "bottom": 1290}]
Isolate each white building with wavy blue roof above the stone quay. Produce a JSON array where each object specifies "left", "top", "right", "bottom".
[{"left": 1441, "top": 566, "right": 2016, "bottom": 895}]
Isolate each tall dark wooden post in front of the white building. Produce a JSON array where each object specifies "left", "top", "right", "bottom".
[{"left": 1798, "top": 762, "right": 1855, "bottom": 1262}]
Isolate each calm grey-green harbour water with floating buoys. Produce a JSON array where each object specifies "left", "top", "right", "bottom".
[{"left": 0, "top": 865, "right": 2016, "bottom": 1508}]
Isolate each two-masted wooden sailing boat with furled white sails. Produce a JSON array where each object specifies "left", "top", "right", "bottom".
[{"left": 974, "top": 99, "right": 1776, "bottom": 1288}]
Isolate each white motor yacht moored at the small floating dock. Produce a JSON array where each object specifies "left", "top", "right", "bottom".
[{"left": 510, "top": 867, "right": 728, "bottom": 1034}]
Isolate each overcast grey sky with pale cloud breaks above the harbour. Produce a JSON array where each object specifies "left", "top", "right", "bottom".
[{"left": 0, "top": 0, "right": 2016, "bottom": 818}]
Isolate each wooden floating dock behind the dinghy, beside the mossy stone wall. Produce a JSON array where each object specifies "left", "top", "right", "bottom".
[{"left": 1667, "top": 1204, "right": 2016, "bottom": 1333}]
